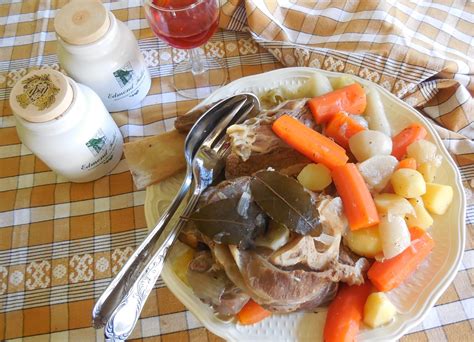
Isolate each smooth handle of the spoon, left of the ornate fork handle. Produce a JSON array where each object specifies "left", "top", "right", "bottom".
[{"left": 92, "top": 168, "right": 192, "bottom": 330}]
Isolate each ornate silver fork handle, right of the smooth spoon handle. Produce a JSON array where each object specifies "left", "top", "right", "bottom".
[{"left": 104, "top": 191, "right": 201, "bottom": 341}]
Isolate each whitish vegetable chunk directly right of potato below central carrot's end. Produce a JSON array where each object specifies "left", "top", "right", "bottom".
[{"left": 379, "top": 214, "right": 410, "bottom": 259}]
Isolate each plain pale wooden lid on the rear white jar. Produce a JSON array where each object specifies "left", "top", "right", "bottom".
[{"left": 54, "top": 0, "right": 110, "bottom": 45}]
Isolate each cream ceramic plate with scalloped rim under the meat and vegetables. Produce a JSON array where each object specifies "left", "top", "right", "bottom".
[{"left": 145, "top": 68, "right": 466, "bottom": 341}]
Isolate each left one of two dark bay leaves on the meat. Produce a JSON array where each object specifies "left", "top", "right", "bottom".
[{"left": 188, "top": 198, "right": 266, "bottom": 248}]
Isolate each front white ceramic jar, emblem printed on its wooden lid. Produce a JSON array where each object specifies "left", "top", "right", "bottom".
[{"left": 10, "top": 69, "right": 123, "bottom": 182}]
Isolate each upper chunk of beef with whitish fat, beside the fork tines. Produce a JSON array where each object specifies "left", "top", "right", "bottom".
[{"left": 226, "top": 99, "right": 317, "bottom": 179}]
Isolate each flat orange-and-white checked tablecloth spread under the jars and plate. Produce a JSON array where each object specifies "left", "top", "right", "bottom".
[{"left": 0, "top": 1, "right": 474, "bottom": 341}]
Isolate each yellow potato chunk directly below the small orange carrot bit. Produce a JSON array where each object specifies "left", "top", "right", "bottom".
[{"left": 390, "top": 169, "right": 426, "bottom": 198}]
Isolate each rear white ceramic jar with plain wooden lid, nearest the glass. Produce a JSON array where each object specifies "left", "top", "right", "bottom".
[{"left": 54, "top": 0, "right": 151, "bottom": 112}]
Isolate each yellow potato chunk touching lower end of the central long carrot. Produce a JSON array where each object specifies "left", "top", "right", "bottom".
[{"left": 345, "top": 227, "right": 382, "bottom": 258}]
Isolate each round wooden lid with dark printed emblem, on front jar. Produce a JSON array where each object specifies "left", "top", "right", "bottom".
[{"left": 10, "top": 69, "right": 74, "bottom": 122}]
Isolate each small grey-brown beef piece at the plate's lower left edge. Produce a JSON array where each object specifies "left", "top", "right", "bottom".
[{"left": 187, "top": 251, "right": 250, "bottom": 316}]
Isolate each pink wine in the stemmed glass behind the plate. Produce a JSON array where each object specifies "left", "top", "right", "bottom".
[{"left": 148, "top": 0, "right": 219, "bottom": 49}]
